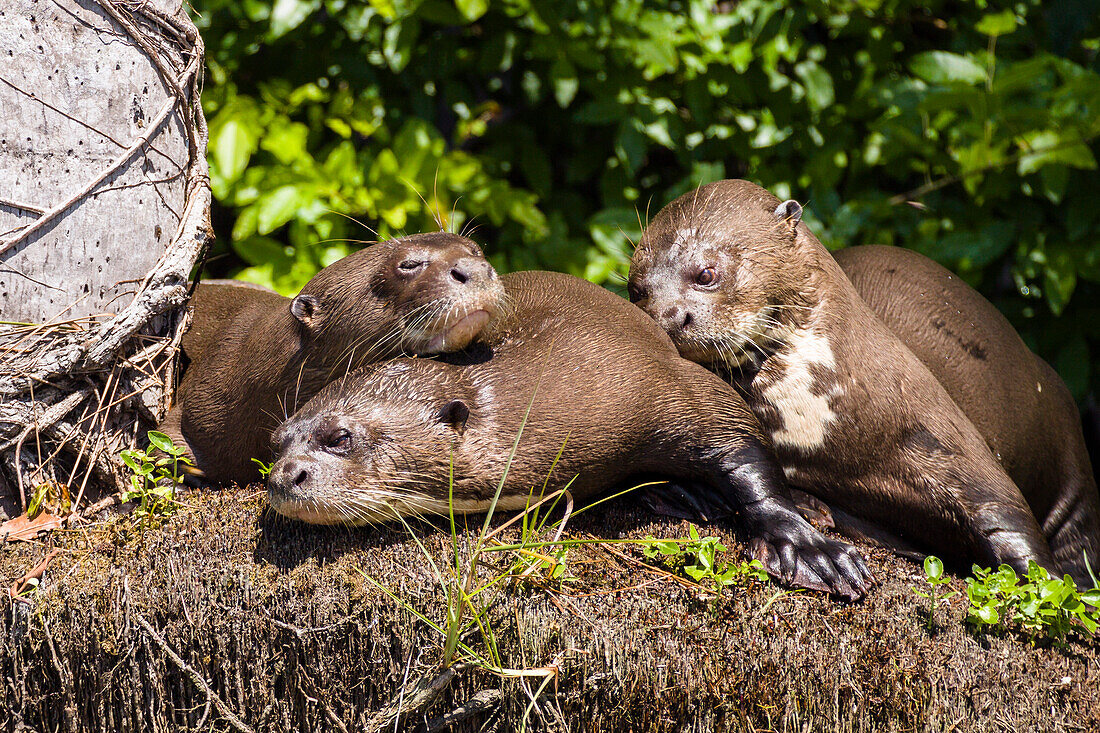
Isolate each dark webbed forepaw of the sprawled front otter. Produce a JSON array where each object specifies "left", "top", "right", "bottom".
[{"left": 751, "top": 528, "right": 875, "bottom": 601}]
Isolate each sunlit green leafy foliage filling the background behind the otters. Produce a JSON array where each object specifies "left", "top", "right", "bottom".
[{"left": 195, "top": 0, "right": 1100, "bottom": 396}]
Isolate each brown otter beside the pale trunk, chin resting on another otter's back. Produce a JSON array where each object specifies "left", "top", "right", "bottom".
[{"left": 161, "top": 232, "right": 504, "bottom": 483}]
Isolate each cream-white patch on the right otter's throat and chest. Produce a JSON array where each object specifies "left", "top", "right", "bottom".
[{"left": 762, "top": 329, "right": 842, "bottom": 450}]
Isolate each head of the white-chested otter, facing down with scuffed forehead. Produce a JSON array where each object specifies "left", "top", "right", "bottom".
[{"left": 627, "top": 180, "right": 812, "bottom": 365}]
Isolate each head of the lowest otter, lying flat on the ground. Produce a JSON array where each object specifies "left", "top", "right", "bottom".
[{"left": 267, "top": 359, "right": 473, "bottom": 525}]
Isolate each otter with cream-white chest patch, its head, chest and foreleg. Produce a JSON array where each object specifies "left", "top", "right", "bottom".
[{"left": 628, "top": 180, "right": 1082, "bottom": 571}]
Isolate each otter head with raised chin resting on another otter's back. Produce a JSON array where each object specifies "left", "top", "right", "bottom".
[{"left": 290, "top": 232, "right": 505, "bottom": 363}]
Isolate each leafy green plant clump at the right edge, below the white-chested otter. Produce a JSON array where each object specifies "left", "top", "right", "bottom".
[{"left": 966, "top": 562, "right": 1100, "bottom": 645}]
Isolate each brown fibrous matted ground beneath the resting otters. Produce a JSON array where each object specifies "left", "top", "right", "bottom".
[{"left": 0, "top": 489, "right": 1100, "bottom": 733}]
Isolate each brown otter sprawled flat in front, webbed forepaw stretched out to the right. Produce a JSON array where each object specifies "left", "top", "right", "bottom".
[{"left": 268, "top": 272, "right": 871, "bottom": 598}]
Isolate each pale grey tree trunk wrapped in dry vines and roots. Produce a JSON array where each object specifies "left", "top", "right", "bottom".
[{"left": 0, "top": 0, "right": 211, "bottom": 519}]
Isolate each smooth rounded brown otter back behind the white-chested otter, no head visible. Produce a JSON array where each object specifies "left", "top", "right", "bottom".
[{"left": 833, "top": 247, "right": 1100, "bottom": 580}]
